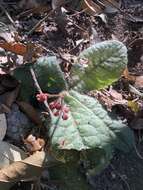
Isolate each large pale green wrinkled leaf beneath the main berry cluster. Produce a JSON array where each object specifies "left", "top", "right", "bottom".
[{"left": 50, "top": 91, "right": 134, "bottom": 152}]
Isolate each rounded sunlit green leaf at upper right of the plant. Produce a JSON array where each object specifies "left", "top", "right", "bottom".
[{"left": 73, "top": 40, "right": 127, "bottom": 90}]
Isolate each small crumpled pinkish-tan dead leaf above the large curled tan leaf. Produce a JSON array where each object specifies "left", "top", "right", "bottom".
[{"left": 23, "top": 134, "right": 45, "bottom": 153}]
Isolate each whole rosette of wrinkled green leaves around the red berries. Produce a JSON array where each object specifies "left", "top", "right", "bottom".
[{"left": 12, "top": 41, "right": 134, "bottom": 190}]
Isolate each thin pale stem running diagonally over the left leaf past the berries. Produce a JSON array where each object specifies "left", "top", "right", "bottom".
[{"left": 30, "top": 67, "right": 53, "bottom": 116}]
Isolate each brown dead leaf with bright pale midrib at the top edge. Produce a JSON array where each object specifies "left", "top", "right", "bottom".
[{"left": 82, "top": 0, "right": 104, "bottom": 15}]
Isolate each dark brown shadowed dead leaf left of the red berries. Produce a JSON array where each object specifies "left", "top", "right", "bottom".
[{"left": 17, "top": 101, "right": 42, "bottom": 126}]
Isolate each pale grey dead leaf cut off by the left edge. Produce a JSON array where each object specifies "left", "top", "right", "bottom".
[{"left": 0, "top": 114, "right": 7, "bottom": 140}]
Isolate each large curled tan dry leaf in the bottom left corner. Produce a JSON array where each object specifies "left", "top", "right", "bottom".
[{"left": 0, "top": 151, "right": 57, "bottom": 190}]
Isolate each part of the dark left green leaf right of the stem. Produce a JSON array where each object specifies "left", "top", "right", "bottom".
[{"left": 34, "top": 56, "right": 67, "bottom": 93}]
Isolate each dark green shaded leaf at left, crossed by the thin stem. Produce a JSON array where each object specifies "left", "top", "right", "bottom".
[{"left": 14, "top": 56, "right": 67, "bottom": 100}]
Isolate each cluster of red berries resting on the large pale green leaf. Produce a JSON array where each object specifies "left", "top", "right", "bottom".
[{"left": 49, "top": 101, "right": 69, "bottom": 120}]
